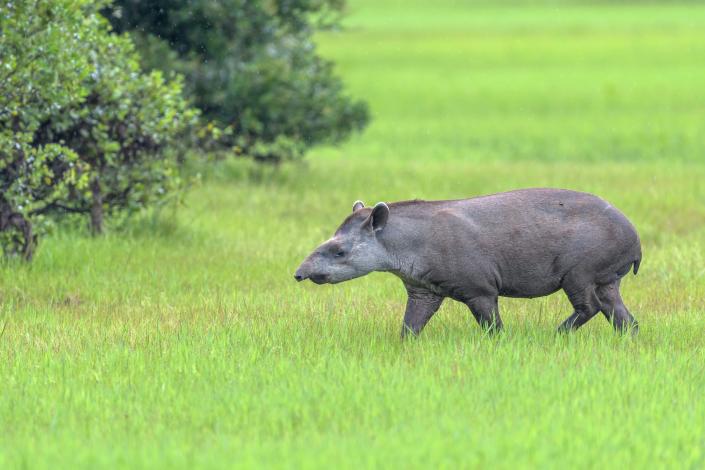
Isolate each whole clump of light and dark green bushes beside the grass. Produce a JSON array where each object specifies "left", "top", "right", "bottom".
[{"left": 0, "top": 0, "right": 368, "bottom": 259}]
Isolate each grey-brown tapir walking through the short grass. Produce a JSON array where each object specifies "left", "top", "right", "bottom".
[{"left": 294, "top": 188, "right": 641, "bottom": 338}]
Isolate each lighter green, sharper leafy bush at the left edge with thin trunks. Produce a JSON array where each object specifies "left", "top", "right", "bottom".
[{"left": 0, "top": 0, "right": 196, "bottom": 259}]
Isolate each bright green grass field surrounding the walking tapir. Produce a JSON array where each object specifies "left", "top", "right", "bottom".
[{"left": 0, "top": 0, "right": 705, "bottom": 469}]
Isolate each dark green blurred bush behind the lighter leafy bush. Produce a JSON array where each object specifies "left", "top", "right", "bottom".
[{"left": 106, "top": 0, "right": 368, "bottom": 161}]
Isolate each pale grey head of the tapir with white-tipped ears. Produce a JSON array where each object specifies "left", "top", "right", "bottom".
[{"left": 294, "top": 201, "right": 389, "bottom": 284}]
